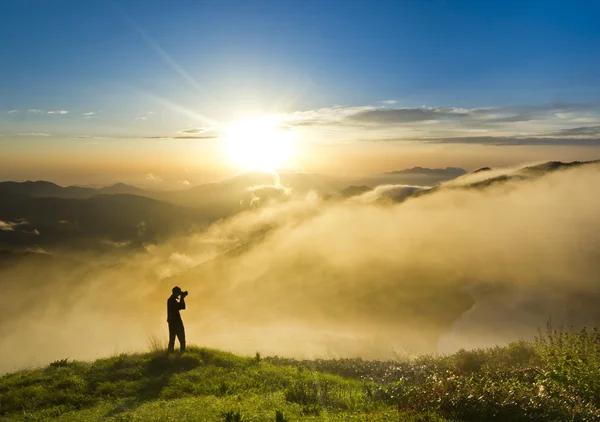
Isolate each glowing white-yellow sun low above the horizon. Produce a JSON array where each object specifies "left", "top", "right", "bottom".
[{"left": 224, "top": 117, "right": 293, "bottom": 172}]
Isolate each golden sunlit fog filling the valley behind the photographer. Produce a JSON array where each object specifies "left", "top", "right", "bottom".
[{"left": 0, "top": 164, "right": 600, "bottom": 371}]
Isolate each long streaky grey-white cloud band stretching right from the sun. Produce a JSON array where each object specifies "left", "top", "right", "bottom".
[{"left": 278, "top": 102, "right": 600, "bottom": 146}]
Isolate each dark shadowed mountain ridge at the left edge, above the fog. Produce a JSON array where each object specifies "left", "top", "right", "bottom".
[{"left": 0, "top": 191, "right": 210, "bottom": 249}]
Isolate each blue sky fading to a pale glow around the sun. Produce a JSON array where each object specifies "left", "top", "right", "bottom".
[{"left": 0, "top": 0, "right": 600, "bottom": 185}]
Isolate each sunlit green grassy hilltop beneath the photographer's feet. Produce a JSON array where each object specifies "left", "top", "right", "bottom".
[{"left": 0, "top": 330, "right": 600, "bottom": 422}]
